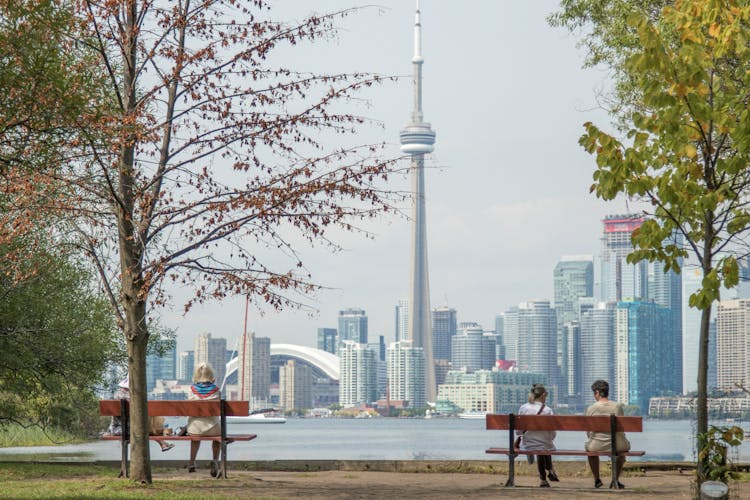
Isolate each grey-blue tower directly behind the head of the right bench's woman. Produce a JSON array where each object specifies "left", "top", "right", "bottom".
[{"left": 518, "top": 300, "right": 560, "bottom": 393}]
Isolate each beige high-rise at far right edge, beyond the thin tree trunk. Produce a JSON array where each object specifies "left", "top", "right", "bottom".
[{"left": 716, "top": 299, "right": 750, "bottom": 391}]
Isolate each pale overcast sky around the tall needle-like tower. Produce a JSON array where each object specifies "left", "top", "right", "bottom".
[{"left": 166, "top": 0, "right": 627, "bottom": 351}]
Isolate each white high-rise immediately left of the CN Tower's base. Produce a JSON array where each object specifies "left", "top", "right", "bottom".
[{"left": 386, "top": 340, "right": 426, "bottom": 408}]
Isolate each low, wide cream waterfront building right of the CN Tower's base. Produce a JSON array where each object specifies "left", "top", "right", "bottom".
[{"left": 436, "top": 370, "right": 554, "bottom": 413}]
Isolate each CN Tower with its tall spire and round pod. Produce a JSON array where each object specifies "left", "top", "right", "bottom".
[{"left": 401, "top": 0, "right": 437, "bottom": 402}]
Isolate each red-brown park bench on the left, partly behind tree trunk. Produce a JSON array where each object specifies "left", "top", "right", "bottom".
[{"left": 99, "top": 399, "right": 257, "bottom": 478}]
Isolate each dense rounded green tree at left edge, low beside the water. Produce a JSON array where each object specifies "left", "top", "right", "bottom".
[{"left": 0, "top": 236, "right": 120, "bottom": 435}]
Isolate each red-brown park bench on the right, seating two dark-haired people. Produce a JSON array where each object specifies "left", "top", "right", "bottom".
[{"left": 485, "top": 413, "right": 646, "bottom": 488}]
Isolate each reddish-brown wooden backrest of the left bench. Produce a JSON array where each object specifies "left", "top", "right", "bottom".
[{"left": 99, "top": 399, "right": 250, "bottom": 417}]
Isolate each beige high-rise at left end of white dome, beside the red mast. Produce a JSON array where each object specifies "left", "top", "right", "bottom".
[{"left": 237, "top": 332, "right": 271, "bottom": 408}]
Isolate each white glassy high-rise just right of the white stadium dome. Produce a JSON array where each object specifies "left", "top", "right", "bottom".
[{"left": 339, "top": 340, "right": 378, "bottom": 408}]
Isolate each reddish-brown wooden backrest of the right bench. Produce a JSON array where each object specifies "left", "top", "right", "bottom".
[{"left": 487, "top": 414, "right": 643, "bottom": 432}]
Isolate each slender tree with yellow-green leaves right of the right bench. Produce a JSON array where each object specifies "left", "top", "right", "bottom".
[{"left": 556, "top": 0, "right": 750, "bottom": 481}]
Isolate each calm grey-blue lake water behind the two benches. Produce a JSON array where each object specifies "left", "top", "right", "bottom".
[{"left": 0, "top": 418, "right": 750, "bottom": 462}]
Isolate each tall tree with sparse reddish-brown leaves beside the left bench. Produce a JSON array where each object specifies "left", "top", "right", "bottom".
[{"left": 4, "top": 0, "right": 402, "bottom": 483}]
